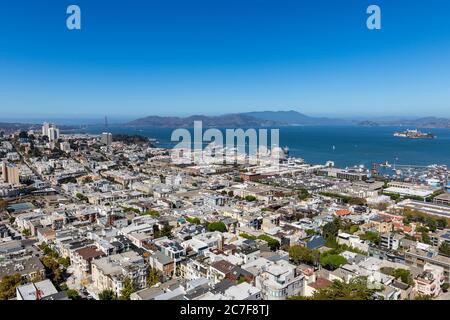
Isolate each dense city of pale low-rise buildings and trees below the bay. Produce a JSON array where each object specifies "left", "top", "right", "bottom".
[{"left": 0, "top": 123, "right": 450, "bottom": 302}]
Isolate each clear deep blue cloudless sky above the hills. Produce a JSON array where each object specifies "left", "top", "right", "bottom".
[{"left": 0, "top": 0, "right": 450, "bottom": 120}]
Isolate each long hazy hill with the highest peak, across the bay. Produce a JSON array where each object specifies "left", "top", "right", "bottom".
[{"left": 127, "top": 111, "right": 351, "bottom": 128}]
